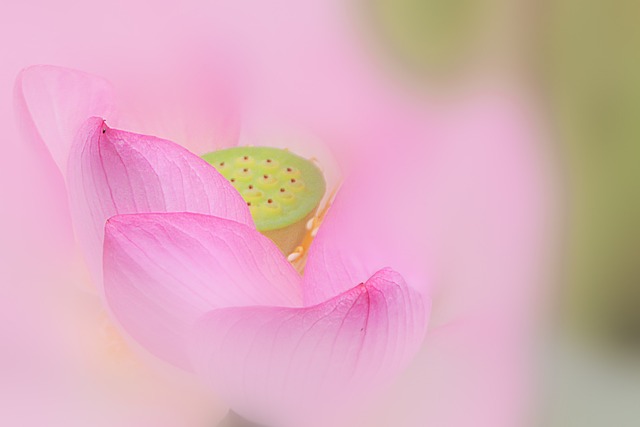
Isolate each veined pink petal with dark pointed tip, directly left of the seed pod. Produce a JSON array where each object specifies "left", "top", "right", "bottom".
[{"left": 68, "top": 117, "right": 253, "bottom": 288}]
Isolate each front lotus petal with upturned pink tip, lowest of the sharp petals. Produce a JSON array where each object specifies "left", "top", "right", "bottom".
[{"left": 193, "top": 268, "right": 429, "bottom": 425}]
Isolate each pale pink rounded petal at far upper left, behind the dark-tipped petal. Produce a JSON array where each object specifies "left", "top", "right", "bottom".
[{"left": 15, "top": 65, "right": 113, "bottom": 175}]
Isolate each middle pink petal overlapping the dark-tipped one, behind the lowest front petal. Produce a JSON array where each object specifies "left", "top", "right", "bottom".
[{"left": 104, "top": 213, "right": 301, "bottom": 366}]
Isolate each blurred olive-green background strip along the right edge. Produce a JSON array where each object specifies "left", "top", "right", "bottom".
[{"left": 542, "top": 0, "right": 640, "bottom": 350}]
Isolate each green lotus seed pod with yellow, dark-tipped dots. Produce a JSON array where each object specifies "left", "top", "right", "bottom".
[{"left": 202, "top": 147, "right": 326, "bottom": 254}]
